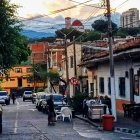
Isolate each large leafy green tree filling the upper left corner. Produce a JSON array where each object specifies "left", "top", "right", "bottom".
[{"left": 0, "top": 0, "right": 30, "bottom": 69}]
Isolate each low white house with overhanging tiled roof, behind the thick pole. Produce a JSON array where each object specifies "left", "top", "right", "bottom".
[{"left": 81, "top": 38, "right": 140, "bottom": 111}]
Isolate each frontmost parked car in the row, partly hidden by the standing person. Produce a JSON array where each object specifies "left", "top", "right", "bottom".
[{"left": 42, "top": 94, "right": 66, "bottom": 113}]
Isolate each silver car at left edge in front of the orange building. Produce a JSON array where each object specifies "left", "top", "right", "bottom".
[{"left": 0, "top": 91, "right": 10, "bottom": 105}]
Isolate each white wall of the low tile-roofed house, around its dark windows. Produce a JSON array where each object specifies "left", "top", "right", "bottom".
[{"left": 88, "top": 60, "right": 140, "bottom": 102}]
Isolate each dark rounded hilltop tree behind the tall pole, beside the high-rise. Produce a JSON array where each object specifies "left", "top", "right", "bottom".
[{"left": 91, "top": 20, "right": 117, "bottom": 33}]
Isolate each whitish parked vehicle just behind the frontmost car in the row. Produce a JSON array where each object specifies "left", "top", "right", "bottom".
[{"left": 35, "top": 92, "right": 46, "bottom": 111}]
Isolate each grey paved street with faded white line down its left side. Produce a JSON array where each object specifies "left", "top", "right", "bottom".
[{"left": 0, "top": 98, "right": 139, "bottom": 140}]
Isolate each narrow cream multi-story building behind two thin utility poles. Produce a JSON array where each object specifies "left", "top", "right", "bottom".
[{"left": 62, "top": 43, "right": 82, "bottom": 97}]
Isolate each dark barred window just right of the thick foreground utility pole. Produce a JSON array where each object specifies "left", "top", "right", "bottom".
[{"left": 119, "top": 77, "right": 125, "bottom": 97}]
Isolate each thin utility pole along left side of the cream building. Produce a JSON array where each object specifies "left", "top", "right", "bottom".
[{"left": 64, "top": 34, "right": 70, "bottom": 99}]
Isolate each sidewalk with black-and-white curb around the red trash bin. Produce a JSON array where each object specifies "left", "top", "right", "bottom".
[{"left": 75, "top": 113, "right": 140, "bottom": 136}]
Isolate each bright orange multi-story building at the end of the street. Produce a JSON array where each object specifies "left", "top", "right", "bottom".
[{"left": 0, "top": 65, "right": 43, "bottom": 95}]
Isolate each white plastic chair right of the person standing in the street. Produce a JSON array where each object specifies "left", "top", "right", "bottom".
[{"left": 61, "top": 107, "right": 72, "bottom": 122}]
